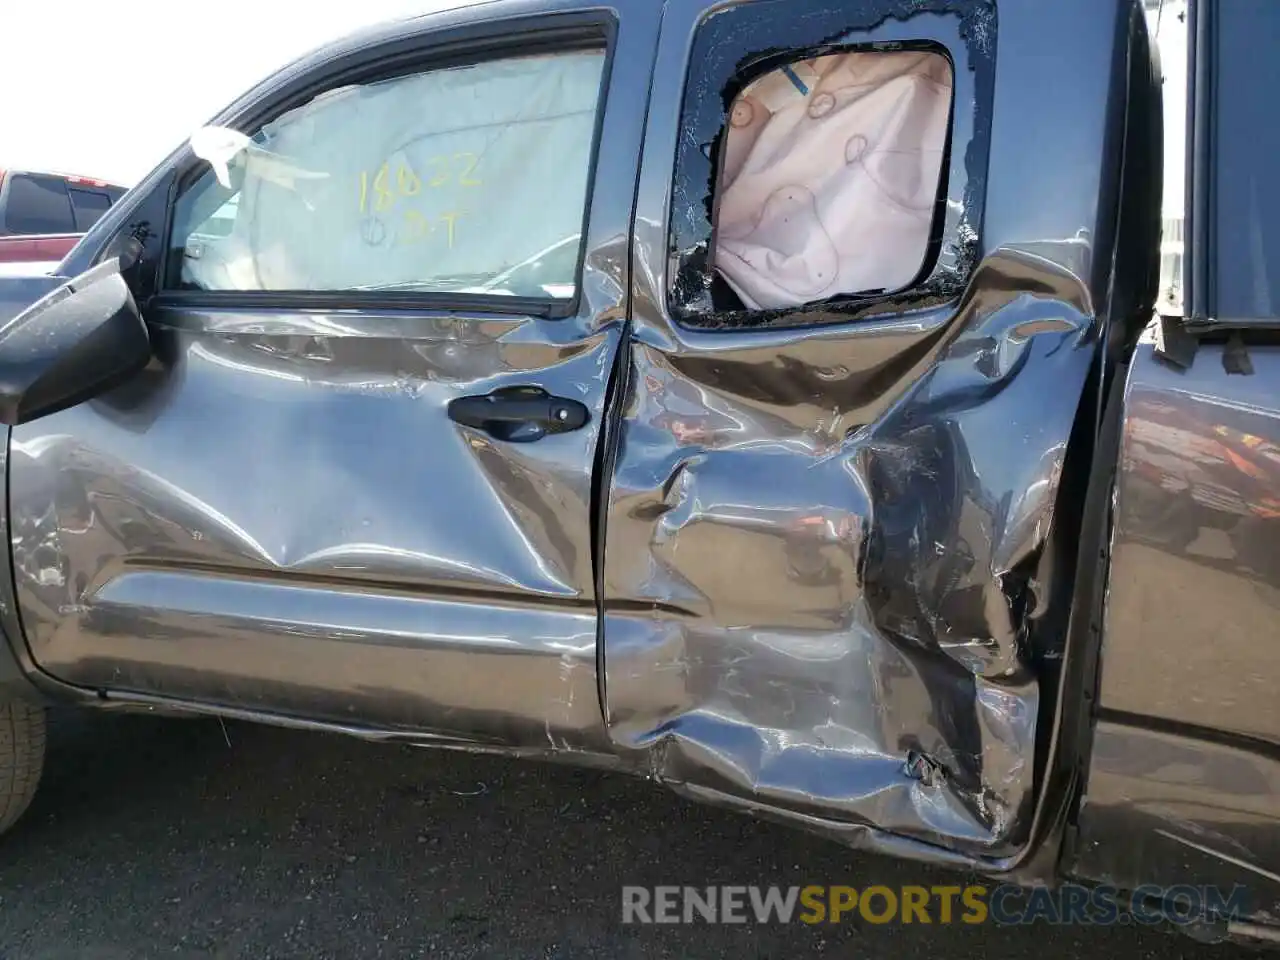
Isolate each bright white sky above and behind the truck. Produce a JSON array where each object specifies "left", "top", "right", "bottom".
[{"left": 0, "top": 0, "right": 1187, "bottom": 215}]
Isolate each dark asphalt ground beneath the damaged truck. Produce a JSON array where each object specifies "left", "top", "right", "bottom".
[{"left": 0, "top": 713, "right": 1240, "bottom": 960}]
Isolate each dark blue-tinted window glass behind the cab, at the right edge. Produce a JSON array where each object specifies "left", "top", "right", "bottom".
[{"left": 1210, "top": 0, "right": 1280, "bottom": 320}]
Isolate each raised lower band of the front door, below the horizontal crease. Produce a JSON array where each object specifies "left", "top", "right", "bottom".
[{"left": 74, "top": 571, "right": 599, "bottom": 751}]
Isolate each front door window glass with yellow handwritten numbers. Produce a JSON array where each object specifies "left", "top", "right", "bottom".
[{"left": 170, "top": 51, "right": 604, "bottom": 298}]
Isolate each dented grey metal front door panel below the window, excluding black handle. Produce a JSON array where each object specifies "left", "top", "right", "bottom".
[{"left": 12, "top": 311, "right": 620, "bottom": 744}]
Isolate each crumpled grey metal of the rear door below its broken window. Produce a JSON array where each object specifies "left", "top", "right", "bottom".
[{"left": 605, "top": 251, "right": 1093, "bottom": 847}]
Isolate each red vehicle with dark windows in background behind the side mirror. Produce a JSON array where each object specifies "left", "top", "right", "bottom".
[{"left": 0, "top": 169, "right": 125, "bottom": 275}]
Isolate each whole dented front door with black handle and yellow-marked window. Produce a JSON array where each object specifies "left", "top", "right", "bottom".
[{"left": 9, "top": 1, "right": 657, "bottom": 750}]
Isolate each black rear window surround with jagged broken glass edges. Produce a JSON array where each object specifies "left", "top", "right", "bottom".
[{"left": 664, "top": 0, "right": 997, "bottom": 333}]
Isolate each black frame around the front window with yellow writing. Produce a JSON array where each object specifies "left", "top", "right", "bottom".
[{"left": 148, "top": 9, "right": 618, "bottom": 320}]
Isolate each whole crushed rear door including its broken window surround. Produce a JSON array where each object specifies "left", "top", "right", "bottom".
[{"left": 604, "top": 0, "right": 1142, "bottom": 855}]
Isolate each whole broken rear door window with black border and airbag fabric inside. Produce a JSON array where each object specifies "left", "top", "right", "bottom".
[{"left": 666, "top": 0, "right": 995, "bottom": 330}]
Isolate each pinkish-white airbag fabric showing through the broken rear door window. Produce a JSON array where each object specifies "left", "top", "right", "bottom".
[{"left": 713, "top": 52, "right": 951, "bottom": 308}]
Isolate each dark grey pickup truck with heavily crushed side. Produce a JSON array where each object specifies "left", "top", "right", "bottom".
[{"left": 0, "top": 0, "right": 1280, "bottom": 941}]
